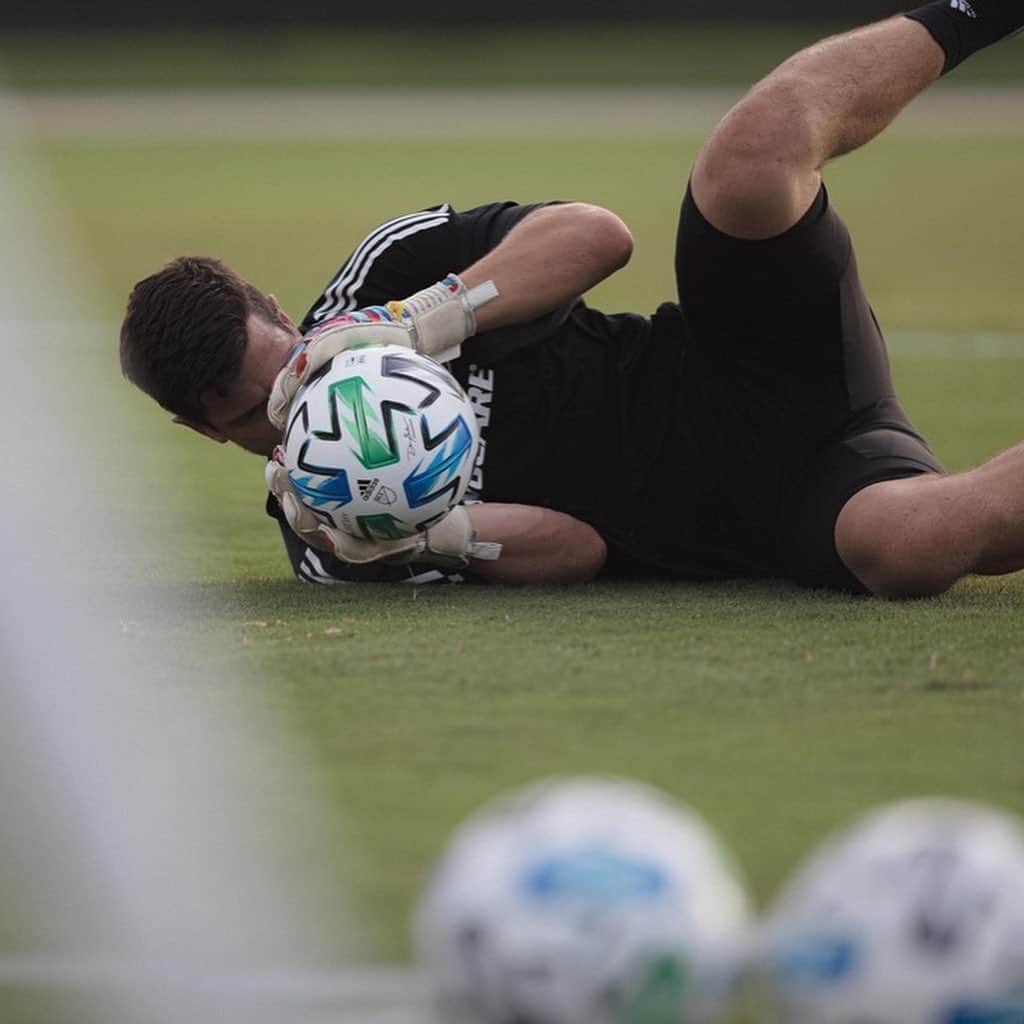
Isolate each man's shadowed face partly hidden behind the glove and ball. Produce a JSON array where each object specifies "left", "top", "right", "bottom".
[{"left": 176, "top": 310, "right": 300, "bottom": 456}]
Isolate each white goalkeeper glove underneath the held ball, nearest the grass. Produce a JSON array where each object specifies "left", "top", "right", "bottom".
[{"left": 265, "top": 447, "right": 502, "bottom": 569}]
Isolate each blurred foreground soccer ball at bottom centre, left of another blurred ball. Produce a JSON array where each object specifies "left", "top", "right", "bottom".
[{"left": 415, "top": 778, "right": 750, "bottom": 1024}]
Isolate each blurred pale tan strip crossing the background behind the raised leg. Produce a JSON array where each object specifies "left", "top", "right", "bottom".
[{"left": 0, "top": 86, "right": 1024, "bottom": 141}]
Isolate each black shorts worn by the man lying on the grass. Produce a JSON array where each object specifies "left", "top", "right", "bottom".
[{"left": 676, "top": 186, "right": 943, "bottom": 592}]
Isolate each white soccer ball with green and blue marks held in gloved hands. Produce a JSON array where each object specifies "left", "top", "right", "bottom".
[{"left": 284, "top": 345, "right": 479, "bottom": 540}]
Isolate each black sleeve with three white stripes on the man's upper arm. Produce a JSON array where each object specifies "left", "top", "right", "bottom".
[{"left": 300, "top": 202, "right": 567, "bottom": 333}]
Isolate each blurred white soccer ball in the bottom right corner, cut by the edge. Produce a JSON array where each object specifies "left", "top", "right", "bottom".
[{"left": 764, "top": 800, "right": 1024, "bottom": 1024}]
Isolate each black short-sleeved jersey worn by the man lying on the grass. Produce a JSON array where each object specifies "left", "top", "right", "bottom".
[{"left": 268, "top": 203, "right": 757, "bottom": 583}]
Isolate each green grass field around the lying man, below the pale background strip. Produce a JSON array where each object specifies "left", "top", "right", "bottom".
[{"left": 18, "top": 75, "right": 1024, "bottom": 959}]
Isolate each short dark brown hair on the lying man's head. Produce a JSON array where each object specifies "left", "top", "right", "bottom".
[{"left": 121, "top": 256, "right": 278, "bottom": 423}]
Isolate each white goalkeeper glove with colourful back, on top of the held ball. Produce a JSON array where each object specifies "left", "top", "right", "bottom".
[{"left": 267, "top": 273, "right": 498, "bottom": 430}]
